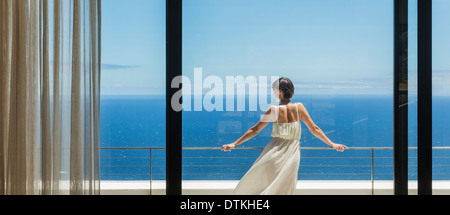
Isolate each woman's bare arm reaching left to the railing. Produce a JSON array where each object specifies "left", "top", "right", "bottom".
[{"left": 221, "top": 106, "right": 274, "bottom": 151}]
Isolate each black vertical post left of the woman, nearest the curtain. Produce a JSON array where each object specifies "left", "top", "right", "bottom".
[{"left": 166, "top": 0, "right": 182, "bottom": 195}]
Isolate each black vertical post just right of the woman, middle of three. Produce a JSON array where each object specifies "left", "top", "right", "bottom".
[{"left": 394, "top": 0, "right": 408, "bottom": 195}]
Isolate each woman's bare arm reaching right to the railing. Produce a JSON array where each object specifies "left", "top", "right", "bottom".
[{"left": 298, "top": 103, "right": 348, "bottom": 151}]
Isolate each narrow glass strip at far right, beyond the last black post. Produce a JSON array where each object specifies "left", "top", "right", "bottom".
[{"left": 432, "top": 0, "right": 450, "bottom": 194}]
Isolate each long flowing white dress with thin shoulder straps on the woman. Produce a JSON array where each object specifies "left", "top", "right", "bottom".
[{"left": 233, "top": 103, "right": 301, "bottom": 195}]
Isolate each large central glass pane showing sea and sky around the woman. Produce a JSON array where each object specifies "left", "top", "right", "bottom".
[{"left": 183, "top": 0, "right": 393, "bottom": 194}]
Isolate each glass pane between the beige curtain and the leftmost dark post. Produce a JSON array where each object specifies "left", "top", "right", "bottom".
[{"left": 100, "top": 0, "right": 165, "bottom": 194}]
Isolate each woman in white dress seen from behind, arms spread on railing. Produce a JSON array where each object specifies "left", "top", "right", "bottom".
[{"left": 221, "top": 77, "right": 348, "bottom": 195}]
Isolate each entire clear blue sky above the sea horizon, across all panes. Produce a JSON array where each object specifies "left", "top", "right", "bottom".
[{"left": 102, "top": 0, "right": 450, "bottom": 95}]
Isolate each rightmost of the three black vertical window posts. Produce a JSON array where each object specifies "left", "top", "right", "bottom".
[{"left": 417, "top": 0, "right": 432, "bottom": 195}]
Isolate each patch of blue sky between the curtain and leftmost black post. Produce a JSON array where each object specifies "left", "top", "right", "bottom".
[{"left": 101, "top": 0, "right": 166, "bottom": 94}]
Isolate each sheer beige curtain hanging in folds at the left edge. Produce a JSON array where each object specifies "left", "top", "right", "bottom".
[{"left": 0, "top": 0, "right": 101, "bottom": 195}]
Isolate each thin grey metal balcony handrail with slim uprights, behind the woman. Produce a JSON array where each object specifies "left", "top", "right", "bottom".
[{"left": 100, "top": 146, "right": 450, "bottom": 195}]
